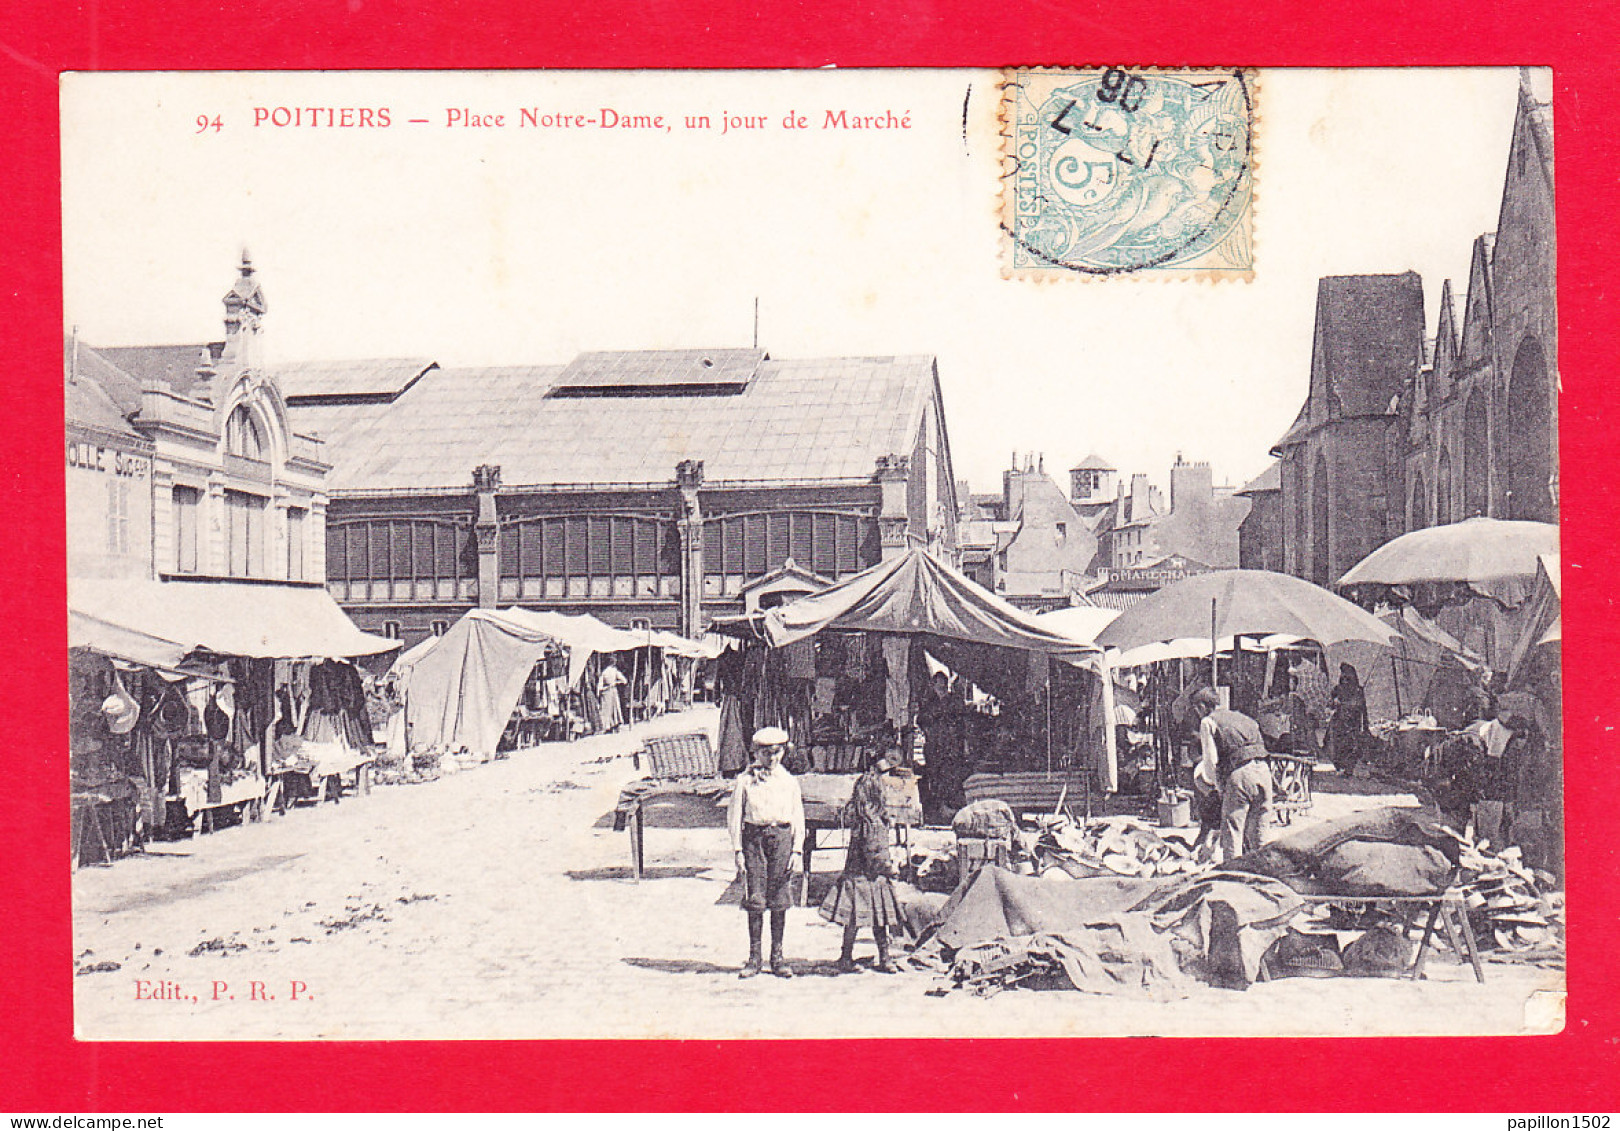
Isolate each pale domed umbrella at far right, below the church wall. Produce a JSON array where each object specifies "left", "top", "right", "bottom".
[{"left": 1338, "top": 519, "right": 1558, "bottom": 588}]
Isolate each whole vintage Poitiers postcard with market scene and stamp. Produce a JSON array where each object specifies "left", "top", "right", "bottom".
[{"left": 62, "top": 68, "right": 1565, "bottom": 1042}]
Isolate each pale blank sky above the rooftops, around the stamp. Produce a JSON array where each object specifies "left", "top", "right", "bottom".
[{"left": 63, "top": 68, "right": 1518, "bottom": 491}]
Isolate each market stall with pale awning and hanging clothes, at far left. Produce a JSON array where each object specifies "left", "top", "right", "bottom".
[{"left": 68, "top": 578, "right": 399, "bottom": 857}]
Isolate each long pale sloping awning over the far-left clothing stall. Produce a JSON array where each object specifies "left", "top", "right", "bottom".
[{"left": 68, "top": 578, "right": 399, "bottom": 668}]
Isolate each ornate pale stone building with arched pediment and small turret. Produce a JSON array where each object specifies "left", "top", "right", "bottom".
[{"left": 66, "top": 253, "right": 329, "bottom": 582}]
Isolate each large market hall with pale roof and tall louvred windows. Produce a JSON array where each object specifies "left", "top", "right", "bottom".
[{"left": 288, "top": 348, "right": 957, "bottom": 643}]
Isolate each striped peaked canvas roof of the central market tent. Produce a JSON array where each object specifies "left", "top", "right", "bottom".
[{"left": 761, "top": 548, "right": 1116, "bottom": 789}]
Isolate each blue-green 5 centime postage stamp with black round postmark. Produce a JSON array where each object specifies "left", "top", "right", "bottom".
[{"left": 1000, "top": 66, "right": 1256, "bottom": 280}]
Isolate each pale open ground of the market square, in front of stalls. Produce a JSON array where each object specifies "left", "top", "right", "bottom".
[{"left": 73, "top": 710, "right": 1563, "bottom": 1040}]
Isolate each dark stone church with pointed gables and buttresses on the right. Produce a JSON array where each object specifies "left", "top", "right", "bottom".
[{"left": 1249, "top": 71, "right": 1558, "bottom": 585}]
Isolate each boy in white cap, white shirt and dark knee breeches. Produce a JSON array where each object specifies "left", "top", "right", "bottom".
[{"left": 726, "top": 726, "right": 805, "bottom": 977}]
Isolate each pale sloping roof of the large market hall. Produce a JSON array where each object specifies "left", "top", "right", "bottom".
[{"left": 290, "top": 350, "right": 943, "bottom": 491}]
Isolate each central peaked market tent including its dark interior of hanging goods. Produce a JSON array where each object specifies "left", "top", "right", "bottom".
[{"left": 719, "top": 549, "right": 1116, "bottom": 809}]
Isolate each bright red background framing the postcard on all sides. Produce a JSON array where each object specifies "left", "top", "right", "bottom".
[{"left": 0, "top": 0, "right": 1620, "bottom": 1113}]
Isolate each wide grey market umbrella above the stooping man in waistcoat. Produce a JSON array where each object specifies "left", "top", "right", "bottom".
[{"left": 1097, "top": 569, "right": 1395, "bottom": 648}]
